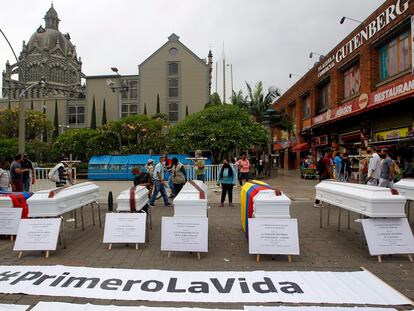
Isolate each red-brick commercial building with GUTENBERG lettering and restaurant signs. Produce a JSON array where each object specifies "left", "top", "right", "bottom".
[{"left": 273, "top": 0, "right": 414, "bottom": 169}]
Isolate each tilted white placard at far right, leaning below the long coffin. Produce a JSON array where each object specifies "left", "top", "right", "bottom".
[{"left": 362, "top": 218, "right": 414, "bottom": 256}]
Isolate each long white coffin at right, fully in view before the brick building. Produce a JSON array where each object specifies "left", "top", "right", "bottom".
[{"left": 315, "top": 180, "right": 406, "bottom": 217}]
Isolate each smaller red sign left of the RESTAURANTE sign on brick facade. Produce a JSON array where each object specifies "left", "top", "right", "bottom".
[{"left": 312, "top": 94, "right": 368, "bottom": 125}]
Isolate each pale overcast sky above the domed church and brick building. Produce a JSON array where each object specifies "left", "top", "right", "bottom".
[{"left": 0, "top": 0, "right": 384, "bottom": 101}]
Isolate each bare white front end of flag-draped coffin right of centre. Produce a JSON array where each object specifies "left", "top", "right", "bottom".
[{"left": 253, "top": 190, "right": 291, "bottom": 218}]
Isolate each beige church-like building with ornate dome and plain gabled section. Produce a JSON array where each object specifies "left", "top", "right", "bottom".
[{"left": 0, "top": 4, "right": 213, "bottom": 131}]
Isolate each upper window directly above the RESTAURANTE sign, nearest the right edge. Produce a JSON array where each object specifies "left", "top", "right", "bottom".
[{"left": 379, "top": 31, "right": 411, "bottom": 81}]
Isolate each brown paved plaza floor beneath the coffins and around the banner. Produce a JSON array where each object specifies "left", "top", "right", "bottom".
[{"left": 0, "top": 172, "right": 414, "bottom": 309}]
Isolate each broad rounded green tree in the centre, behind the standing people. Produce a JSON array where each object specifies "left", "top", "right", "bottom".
[{"left": 168, "top": 105, "right": 269, "bottom": 163}]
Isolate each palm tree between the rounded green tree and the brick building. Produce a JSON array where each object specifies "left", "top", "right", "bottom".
[{"left": 246, "top": 81, "right": 281, "bottom": 123}]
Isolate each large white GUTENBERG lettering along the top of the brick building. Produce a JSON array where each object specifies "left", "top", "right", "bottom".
[{"left": 318, "top": 0, "right": 410, "bottom": 78}]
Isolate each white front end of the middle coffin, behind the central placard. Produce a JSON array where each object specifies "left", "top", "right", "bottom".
[{"left": 174, "top": 191, "right": 207, "bottom": 217}]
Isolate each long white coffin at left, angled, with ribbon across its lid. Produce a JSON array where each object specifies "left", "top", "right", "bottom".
[{"left": 26, "top": 182, "right": 99, "bottom": 217}]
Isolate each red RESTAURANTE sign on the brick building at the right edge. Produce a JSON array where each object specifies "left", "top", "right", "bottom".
[{"left": 369, "top": 75, "right": 414, "bottom": 106}]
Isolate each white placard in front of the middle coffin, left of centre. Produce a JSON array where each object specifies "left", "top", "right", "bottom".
[{"left": 161, "top": 217, "right": 208, "bottom": 252}]
